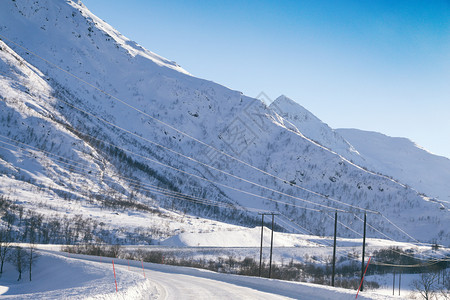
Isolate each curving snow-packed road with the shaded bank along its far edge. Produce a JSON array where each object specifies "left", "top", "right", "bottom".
[{"left": 66, "top": 251, "right": 392, "bottom": 300}]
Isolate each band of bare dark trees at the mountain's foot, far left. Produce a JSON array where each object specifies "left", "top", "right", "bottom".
[{"left": 0, "top": 195, "right": 161, "bottom": 245}]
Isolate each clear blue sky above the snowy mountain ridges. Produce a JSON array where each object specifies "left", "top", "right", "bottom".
[{"left": 83, "top": 0, "right": 450, "bottom": 158}]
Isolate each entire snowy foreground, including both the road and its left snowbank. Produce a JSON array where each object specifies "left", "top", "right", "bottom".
[{"left": 0, "top": 251, "right": 398, "bottom": 300}]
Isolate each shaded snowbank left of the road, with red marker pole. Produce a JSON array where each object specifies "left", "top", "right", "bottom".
[{"left": 0, "top": 251, "right": 155, "bottom": 299}]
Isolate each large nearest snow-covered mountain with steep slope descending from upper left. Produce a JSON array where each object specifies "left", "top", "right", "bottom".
[{"left": 0, "top": 0, "right": 450, "bottom": 244}]
